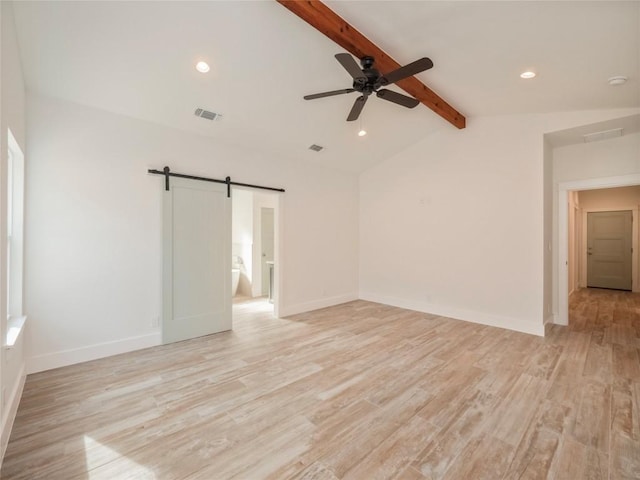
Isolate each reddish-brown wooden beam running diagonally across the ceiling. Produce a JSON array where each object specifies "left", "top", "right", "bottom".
[{"left": 276, "top": 0, "right": 466, "bottom": 128}]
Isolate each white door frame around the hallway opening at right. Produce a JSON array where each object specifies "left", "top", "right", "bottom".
[{"left": 554, "top": 173, "right": 640, "bottom": 325}]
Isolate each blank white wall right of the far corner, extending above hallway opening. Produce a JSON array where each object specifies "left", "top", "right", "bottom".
[{"left": 360, "top": 111, "right": 633, "bottom": 335}]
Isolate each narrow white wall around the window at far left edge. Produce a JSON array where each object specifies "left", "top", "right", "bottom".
[{"left": 0, "top": 1, "right": 29, "bottom": 462}]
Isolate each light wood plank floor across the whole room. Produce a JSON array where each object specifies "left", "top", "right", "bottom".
[{"left": 2, "top": 290, "right": 640, "bottom": 480}]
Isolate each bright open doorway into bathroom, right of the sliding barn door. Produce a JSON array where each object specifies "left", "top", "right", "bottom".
[{"left": 231, "top": 188, "right": 281, "bottom": 319}]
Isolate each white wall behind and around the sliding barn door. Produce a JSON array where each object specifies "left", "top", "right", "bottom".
[{"left": 25, "top": 96, "right": 358, "bottom": 371}]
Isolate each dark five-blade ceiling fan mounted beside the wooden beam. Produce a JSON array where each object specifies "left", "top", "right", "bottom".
[{"left": 304, "top": 53, "right": 433, "bottom": 122}]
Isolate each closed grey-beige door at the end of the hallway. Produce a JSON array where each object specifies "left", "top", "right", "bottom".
[{"left": 587, "top": 210, "right": 633, "bottom": 290}]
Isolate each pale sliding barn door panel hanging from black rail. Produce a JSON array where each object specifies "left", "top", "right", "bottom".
[{"left": 162, "top": 177, "right": 231, "bottom": 343}]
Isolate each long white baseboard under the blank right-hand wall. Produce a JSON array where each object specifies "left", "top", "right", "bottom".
[{"left": 360, "top": 292, "right": 544, "bottom": 337}]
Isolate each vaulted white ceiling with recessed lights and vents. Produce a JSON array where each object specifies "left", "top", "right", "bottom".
[{"left": 14, "top": 0, "right": 640, "bottom": 171}]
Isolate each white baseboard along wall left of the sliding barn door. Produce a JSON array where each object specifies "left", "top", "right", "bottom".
[{"left": 27, "top": 332, "right": 162, "bottom": 373}]
